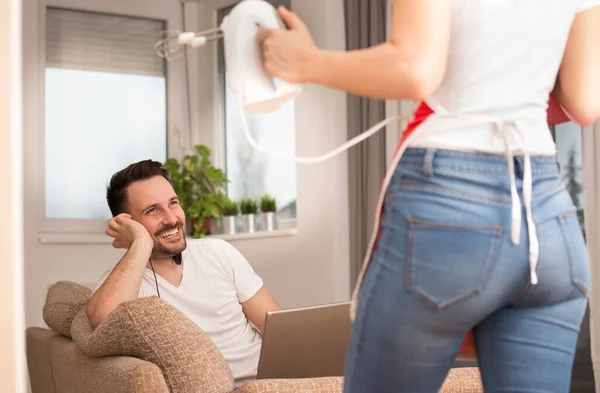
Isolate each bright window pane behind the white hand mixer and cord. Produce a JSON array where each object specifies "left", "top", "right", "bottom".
[{"left": 218, "top": 0, "right": 296, "bottom": 222}]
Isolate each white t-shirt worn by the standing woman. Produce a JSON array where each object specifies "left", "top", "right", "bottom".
[{"left": 411, "top": 0, "right": 600, "bottom": 155}]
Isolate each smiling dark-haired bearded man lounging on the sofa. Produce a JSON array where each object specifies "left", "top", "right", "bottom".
[{"left": 86, "top": 160, "right": 281, "bottom": 386}]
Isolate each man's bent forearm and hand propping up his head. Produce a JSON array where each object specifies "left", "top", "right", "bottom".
[{"left": 85, "top": 215, "right": 154, "bottom": 328}]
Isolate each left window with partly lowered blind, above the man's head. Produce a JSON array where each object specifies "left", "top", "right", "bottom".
[{"left": 44, "top": 8, "right": 167, "bottom": 220}]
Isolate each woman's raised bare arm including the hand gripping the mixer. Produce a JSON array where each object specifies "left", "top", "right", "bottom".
[{"left": 259, "top": 0, "right": 451, "bottom": 100}]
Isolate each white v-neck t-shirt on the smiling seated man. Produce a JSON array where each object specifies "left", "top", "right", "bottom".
[{"left": 98, "top": 239, "right": 263, "bottom": 386}]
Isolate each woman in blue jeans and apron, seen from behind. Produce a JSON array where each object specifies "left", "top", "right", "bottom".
[{"left": 259, "top": 0, "right": 600, "bottom": 393}]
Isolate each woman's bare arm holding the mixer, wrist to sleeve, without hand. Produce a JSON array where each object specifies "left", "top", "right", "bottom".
[{"left": 308, "top": 0, "right": 450, "bottom": 101}]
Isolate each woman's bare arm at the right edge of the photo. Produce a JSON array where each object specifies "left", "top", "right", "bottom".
[{"left": 554, "top": 7, "right": 600, "bottom": 125}]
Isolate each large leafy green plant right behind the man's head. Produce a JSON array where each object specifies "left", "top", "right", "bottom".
[{"left": 164, "top": 145, "right": 228, "bottom": 238}]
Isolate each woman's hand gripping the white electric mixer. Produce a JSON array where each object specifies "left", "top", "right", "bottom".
[{"left": 257, "top": 7, "right": 318, "bottom": 83}]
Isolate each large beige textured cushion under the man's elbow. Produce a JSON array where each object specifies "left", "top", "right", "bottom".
[{"left": 71, "top": 296, "right": 234, "bottom": 393}]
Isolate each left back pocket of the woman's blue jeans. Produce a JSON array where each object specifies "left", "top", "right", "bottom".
[{"left": 406, "top": 218, "right": 502, "bottom": 310}]
